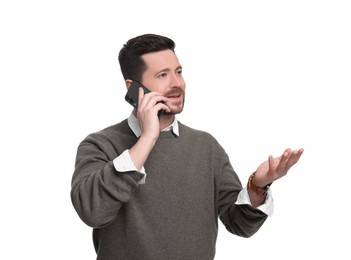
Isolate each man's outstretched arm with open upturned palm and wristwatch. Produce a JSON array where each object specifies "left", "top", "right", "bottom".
[{"left": 218, "top": 149, "right": 303, "bottom": 237}]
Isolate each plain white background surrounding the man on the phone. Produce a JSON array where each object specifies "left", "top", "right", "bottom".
[{"left": 0, "top": 0, "right": 351, "bottom": 260}]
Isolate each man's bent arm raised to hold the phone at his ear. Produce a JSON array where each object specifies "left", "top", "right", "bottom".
[{"left": 71, "top": 87, "right": 170, "bottom": 227}]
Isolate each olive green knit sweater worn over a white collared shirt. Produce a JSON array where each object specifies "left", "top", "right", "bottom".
[{"left": 71, "top": 120, "right": 267, "bottom": 260}]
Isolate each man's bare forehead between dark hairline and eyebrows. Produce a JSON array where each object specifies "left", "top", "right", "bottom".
[{"left": 141, "top": 50, "right": 180, "bottom": 71}]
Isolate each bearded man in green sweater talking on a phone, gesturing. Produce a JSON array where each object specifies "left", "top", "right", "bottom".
[{"left": 71, "top": 34, "right": 303, "bottom": 260}]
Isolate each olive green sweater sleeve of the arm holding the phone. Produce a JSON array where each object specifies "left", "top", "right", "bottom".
[{"left": 71, "top": 137, "right": 143, "bottom": 227}]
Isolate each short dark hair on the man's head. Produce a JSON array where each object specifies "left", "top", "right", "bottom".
[{"left": 118, "top": 34, "right": 175, "bottom": 82}]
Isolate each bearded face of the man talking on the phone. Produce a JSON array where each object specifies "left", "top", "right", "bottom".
[{"left": 141, "top": 50, "right": 185, "bottom": 114}]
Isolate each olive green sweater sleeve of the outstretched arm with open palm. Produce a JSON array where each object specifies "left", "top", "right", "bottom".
[{"left": 218, "top": 155, "right": 268, "bottom": 237}]
